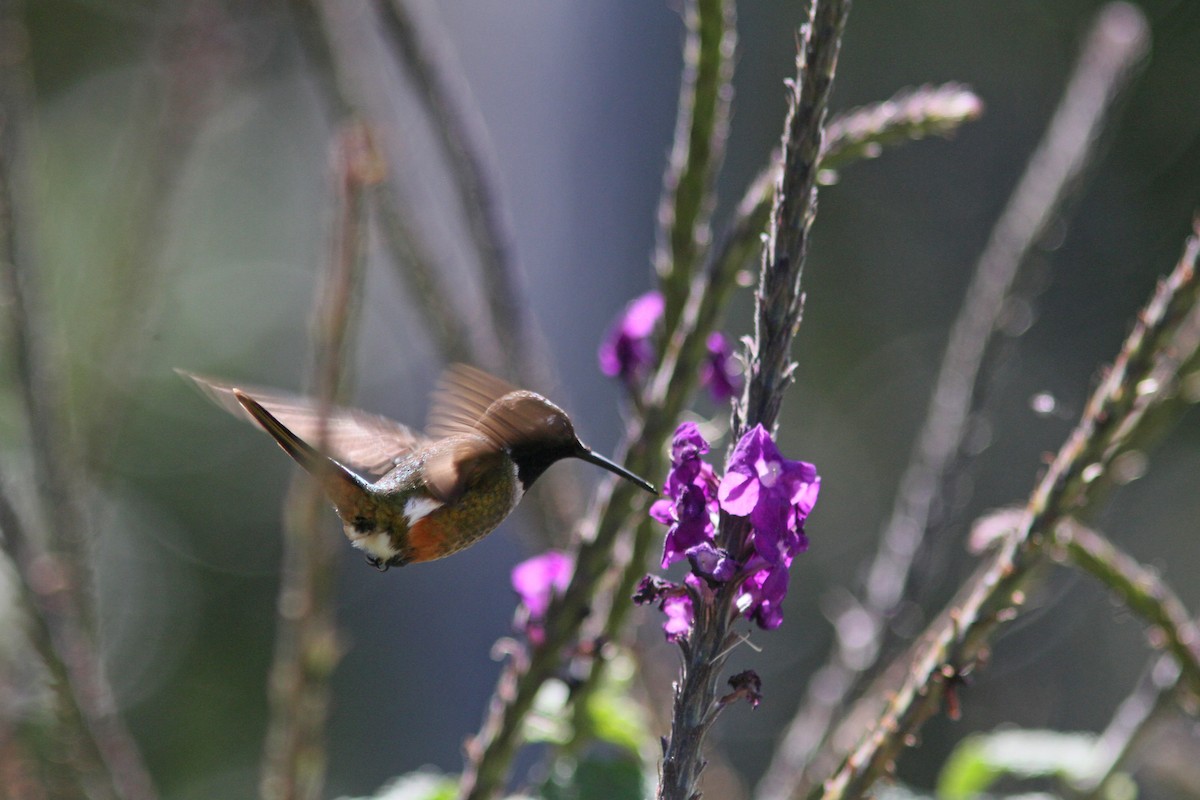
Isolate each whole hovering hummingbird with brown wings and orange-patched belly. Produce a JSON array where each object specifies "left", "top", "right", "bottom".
[{"left": 176, "top": 365, "right": 658, "bottom": 571}]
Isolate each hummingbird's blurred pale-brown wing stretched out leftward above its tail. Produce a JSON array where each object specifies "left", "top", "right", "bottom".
[{"left": 175, "top": 369, "right": 427, "bottom": 475}]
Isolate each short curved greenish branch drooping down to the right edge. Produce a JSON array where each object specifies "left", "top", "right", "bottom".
[{"left": 1054, "top": 519, "right": 1200, "bottom": 698}]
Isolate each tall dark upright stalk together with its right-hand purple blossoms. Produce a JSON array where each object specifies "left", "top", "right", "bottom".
[{"left": 659, "top": 0, "right": 850, "bottom": 800}]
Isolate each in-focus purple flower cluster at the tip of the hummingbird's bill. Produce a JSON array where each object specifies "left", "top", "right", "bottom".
[{"left": 635, "top": 422, "right": 821, "bottom": 640}]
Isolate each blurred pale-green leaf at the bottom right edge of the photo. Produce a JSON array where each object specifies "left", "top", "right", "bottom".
[{"left": 937, "top": 730, "right": 1096, "bottom": 800}]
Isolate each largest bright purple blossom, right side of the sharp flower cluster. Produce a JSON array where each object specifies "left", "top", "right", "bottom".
[{"left": 716, "top": 425, "right": 821, "bottom": 565}]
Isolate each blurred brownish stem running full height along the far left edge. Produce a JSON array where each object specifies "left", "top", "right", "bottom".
[{"left": 0, "top": 1, "right": 157, "bottom": 800}]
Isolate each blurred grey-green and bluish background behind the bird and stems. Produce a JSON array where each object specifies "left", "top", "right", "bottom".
[{"left": 0, "top": 0, "right": 1200, "bottom": 800}]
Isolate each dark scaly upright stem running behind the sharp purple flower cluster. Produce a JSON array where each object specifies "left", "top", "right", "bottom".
[{"left": 658, "top": 6, "right": 850, "bottom": 800}]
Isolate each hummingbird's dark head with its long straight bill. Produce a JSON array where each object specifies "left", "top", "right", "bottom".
[{"left": 475, "top": 390, "right": 658, "bottom": 494}]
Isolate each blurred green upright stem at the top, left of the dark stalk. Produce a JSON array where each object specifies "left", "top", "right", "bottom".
[{"left": 654, "top": 0, "right": 737, "bottom": 338}]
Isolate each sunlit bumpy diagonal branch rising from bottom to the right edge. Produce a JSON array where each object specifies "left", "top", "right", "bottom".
[{"left": 811, "top": 221, "right": 1200, "bottom": 800}]
